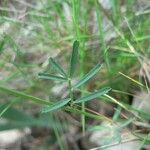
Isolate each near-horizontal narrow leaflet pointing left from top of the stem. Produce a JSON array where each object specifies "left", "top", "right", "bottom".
[{"left": 39, "top": 73, "right": 67, "bottom": 81}]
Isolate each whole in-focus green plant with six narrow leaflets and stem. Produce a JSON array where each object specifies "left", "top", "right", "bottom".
[{"left": 39, "top": 41, "right": 111, "bottom": 113}]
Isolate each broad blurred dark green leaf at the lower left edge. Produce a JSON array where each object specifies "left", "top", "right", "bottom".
[{"left": 0, "top": 104, "right": 64, "bottom": 131}]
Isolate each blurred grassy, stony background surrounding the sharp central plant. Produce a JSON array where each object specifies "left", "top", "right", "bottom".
[{"left": 0, "top": 0, "right": 150, "bottom": 150}]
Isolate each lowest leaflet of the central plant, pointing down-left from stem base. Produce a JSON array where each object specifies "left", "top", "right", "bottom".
[{"left": 42, "top": 98, "right": 71, "bottom": 113}]
